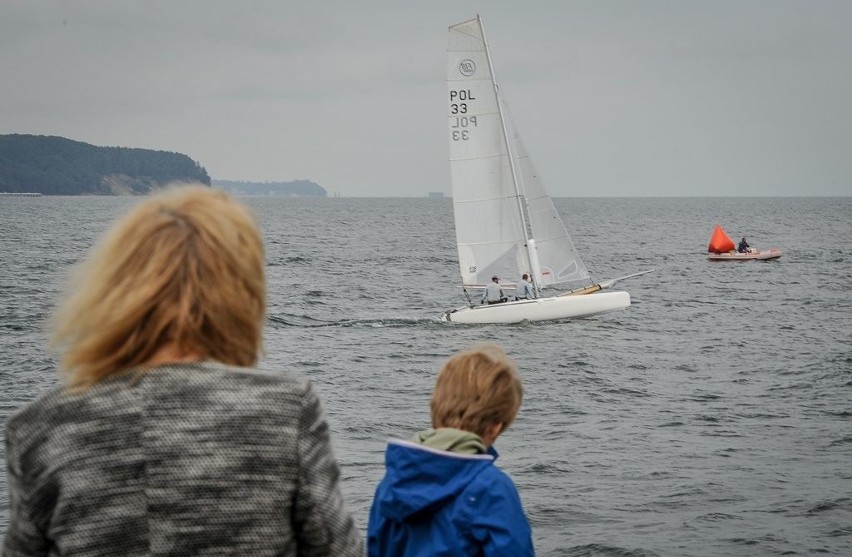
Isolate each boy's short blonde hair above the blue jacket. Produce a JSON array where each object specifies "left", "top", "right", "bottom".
[{"left": 430, "top": 345, "right": 524, "bottom": 435}]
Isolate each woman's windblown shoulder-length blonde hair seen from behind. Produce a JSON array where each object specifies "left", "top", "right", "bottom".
[{"left": 53, "top": 185, "right": 266, "bottom": 388}]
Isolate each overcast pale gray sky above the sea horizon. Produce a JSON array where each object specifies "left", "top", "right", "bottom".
[{"left": 0, "top": 0, "right": 852, "bottom": 197}]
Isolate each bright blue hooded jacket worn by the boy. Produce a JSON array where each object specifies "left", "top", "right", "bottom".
[{"left": 367, "top": 439, "right": 535, "bottom": 557}]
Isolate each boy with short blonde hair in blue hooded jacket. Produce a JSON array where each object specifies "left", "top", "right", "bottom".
[{"left": 367, "top": 346, "right": 534, "bottom": 557}]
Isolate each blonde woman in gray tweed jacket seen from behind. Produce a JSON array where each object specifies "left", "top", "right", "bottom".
[{"left": 3, "top": 185, "right": 363, "bottom": 556}]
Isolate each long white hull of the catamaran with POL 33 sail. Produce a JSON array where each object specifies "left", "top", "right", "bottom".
[{"left": 441, "top": 292, "right": 630, "bottom": 323}]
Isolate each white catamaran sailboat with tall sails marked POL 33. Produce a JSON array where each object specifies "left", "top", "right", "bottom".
[{"left": 441, "top": 15, "right": 650, "bottom": 323}]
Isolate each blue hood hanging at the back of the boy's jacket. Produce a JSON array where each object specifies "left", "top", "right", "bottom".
[{"left": 376, "top": 438, "right": 497, "bottom": 521}]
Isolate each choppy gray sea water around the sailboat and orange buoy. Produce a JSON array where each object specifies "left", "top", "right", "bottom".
[{"left": 0, "top": 197, "right": 852, "bottom": 556}]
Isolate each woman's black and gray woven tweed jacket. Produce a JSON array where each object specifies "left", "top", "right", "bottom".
[{"left": 3, "top": 363, "right": 364, "bottom": 556}]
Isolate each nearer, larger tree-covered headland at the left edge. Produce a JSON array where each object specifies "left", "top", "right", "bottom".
[{"left": 0, "top": 134, "right": 210, "bottom": 195}]
